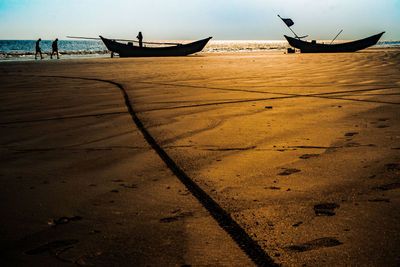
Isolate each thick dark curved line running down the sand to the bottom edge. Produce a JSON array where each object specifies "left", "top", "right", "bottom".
[{"left": 39, "top": 76, "right": 278, "bottom": 266}]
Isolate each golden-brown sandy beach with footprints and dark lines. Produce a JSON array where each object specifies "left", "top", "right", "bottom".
[{"left": 0, "top": 49, "right": 400, "bottom": 266}]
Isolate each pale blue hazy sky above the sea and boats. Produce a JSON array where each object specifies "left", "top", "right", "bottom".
[{"left": 0, "top": 0, "right": 400, "bottom": 40}]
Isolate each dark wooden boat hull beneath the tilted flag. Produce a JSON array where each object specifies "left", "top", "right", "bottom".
[{"left": 284, "top": 32, "right": 385, "bottom": 53}]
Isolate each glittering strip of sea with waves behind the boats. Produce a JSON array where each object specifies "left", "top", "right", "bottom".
[{"left": 0, "top": 40, "right": 400, "bottom": 61}]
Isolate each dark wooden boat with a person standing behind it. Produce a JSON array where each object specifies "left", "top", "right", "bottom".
[{"left": 100, "top": 36, "right": 212, "bottom": 57}]
